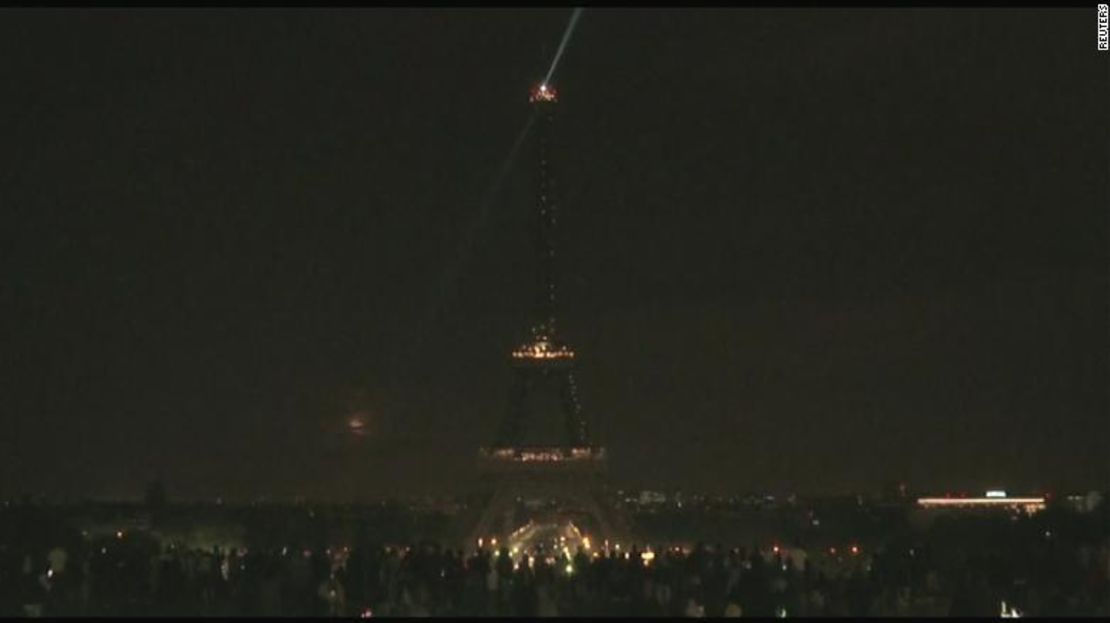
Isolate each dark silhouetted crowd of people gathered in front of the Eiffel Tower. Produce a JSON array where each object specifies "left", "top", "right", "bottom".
[{"left": 0, "top": 528, "right": 1108, "bottom": 616}]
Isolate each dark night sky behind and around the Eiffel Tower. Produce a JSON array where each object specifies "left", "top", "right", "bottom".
[{"left": 0, "top": 7, "right": 1110, "bottom": 499}]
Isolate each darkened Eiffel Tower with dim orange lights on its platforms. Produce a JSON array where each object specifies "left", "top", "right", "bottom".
[{"left": 459, "top": 84, "right": 627, "bottom": 546}]
